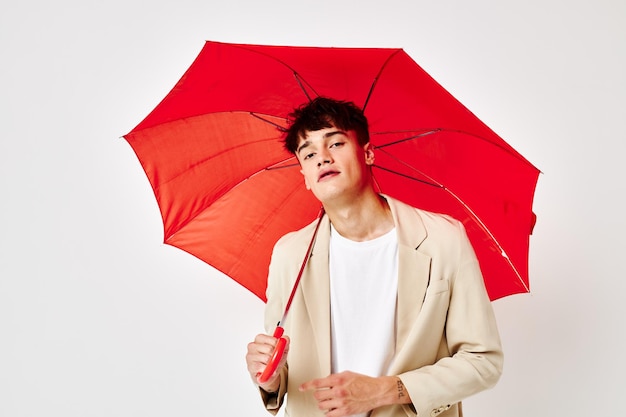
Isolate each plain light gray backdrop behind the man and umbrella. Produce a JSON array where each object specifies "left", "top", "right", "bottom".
[{"left": 0, "top": 0, "right": 626, "bottom": 417}]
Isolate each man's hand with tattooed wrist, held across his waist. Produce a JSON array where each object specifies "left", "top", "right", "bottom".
[{"left": 300, "top": 372, "right": 411, "bottom": 417}]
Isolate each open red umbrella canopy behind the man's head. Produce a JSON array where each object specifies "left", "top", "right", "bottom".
[{"left": 125, "top": 42, "right": 539, "bottom": 300}]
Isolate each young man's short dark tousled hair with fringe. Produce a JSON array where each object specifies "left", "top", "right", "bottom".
[{"left": 284, "top": 97, "right": 370, "bottom": 154}]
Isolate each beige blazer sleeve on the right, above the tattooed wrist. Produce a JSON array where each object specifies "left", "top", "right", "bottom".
[{"left": 398, "top": 219, "right": 503, "bottom": 416}]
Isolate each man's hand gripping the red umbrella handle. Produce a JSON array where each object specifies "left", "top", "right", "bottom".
[{"left": 246, "top": 334, "right": 289, "bottom": 392}]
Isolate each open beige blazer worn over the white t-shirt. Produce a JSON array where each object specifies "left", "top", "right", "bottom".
[{"left": 261, "top": 197, "right": 503, "bottom": 417}]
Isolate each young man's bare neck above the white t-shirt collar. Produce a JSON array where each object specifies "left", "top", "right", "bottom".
[{"left": 324, "top": 193, "right": 394, "bottom": 242}]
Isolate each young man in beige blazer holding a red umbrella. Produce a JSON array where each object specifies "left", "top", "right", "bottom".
[{"left": 246, "top": 98, "right": 503, "bottom": 417}]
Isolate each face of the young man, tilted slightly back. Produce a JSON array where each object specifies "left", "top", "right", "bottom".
[{"left": 296, "top": 127, "right": 374, "bottom": 204}]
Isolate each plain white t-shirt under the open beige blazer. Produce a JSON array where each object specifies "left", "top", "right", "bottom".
[{"left": 329, "top": 226, "right": 398, "bottom": 377}]
